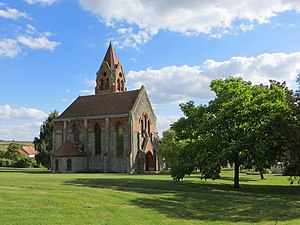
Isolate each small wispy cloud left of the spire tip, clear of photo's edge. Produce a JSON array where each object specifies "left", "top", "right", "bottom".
[{"left": 18, "top": 35, "right": 61, "bottom": 51}]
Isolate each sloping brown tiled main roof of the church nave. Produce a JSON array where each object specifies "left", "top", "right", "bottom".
[{"left": 58, "top": 89, "right": 141, "bottom": 119}]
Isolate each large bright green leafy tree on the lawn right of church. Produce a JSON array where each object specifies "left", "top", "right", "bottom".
[{"left": 172, "top": 77, "right": 295, "bottom": 188}]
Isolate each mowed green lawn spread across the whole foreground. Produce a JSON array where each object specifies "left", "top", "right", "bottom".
[{"left": 0, "top": 168, "right": 300, "bottom": 225}]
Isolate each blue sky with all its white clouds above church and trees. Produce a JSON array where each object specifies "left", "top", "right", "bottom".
[{"left": 0, "top": 0, "right": 300, "bottom": 141}]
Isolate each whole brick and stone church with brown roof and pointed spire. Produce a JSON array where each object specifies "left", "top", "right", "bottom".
[{"left": 51, "top": 43, "right": 160, "bottom": 173}]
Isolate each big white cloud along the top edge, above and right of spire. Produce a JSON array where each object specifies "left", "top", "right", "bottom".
[{"left": 79, "top": 0, "right": 300, "bottom": 47}]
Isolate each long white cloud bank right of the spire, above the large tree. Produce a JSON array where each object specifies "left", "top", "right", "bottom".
[{"left": 127, "top": 52, "right": 300, "bottom": 104}]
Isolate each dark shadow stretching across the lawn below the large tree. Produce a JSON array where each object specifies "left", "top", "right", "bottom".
[{"left": 66, "top": 177, "right": 300, "bottom": 224}]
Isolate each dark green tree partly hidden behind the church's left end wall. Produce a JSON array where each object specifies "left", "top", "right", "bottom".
[{"left": 33, "top": 110, "right": 59, "bottom": 168}]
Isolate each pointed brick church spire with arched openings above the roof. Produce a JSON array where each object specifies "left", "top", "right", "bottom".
[{"left": 95, "top": 42, "right": 126, "bottom": 95}]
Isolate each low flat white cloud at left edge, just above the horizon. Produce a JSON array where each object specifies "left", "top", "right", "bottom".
[{"left": 0, "top": 105, "right": 47, "bottom": 120}]
